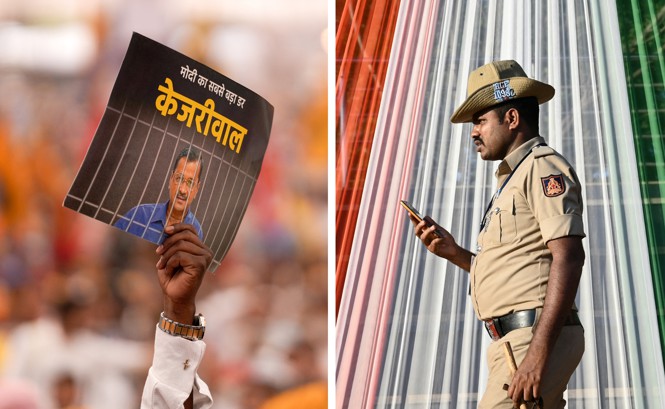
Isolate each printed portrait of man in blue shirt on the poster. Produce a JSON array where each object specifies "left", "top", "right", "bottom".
[{"left": 114, "top": 147, "right": 203, "bottom": 244}]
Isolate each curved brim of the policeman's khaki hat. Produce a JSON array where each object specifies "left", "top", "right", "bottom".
[{"left": 450, "top": 77, "right": 554, "bottom": 124}]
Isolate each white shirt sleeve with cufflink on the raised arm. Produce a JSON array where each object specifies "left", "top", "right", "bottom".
[{"left": 141, "top": 327, "right": 212, "bottom": 409}]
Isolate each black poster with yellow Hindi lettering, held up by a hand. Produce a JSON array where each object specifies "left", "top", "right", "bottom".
[{"left": 64, "top": 33, "right": 273, "bottom": 271}]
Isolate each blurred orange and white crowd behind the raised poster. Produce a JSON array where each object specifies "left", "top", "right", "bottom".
[{"left": 0, "top": 0, "right": 327, "bottom": 409}]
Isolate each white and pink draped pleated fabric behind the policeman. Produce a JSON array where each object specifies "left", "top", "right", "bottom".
[{"left": 336, "top": 0, "right": 665, "bottom": 408}]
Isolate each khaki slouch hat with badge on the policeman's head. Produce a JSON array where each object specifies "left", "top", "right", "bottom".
[{"left": 450, "top": 60, "right": 554, "bottom": 124}]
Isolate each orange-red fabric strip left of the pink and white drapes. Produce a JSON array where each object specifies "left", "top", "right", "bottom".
[{"left": 335, "top": 0, "right": 400, "bottom": 314}]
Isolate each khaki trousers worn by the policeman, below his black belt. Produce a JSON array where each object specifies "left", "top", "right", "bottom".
[{"left": 478, "top": 325, "right": 584, "bottom": 409}]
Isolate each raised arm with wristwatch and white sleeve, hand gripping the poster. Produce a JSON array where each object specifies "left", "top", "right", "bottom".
[{"left": 150, "top": 223, "right": 212, "bottom": 409}]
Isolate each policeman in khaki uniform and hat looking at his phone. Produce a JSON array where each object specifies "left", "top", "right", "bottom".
[{"left": 411, "top": 61, "right": 585, "bottom": 409}]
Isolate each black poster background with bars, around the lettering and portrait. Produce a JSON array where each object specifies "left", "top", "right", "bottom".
[{"left": 64, "top": 33, "right": 274, "bottom": 271}]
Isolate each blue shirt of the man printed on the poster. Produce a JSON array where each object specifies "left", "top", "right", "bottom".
[{"left": 114, "top": 202, "right": 203, "bottom": 244}]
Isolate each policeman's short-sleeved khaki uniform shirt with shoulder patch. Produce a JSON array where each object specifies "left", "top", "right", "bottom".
[{"left": 471, "top": 137, "right": 585, "bottom": 320}]
